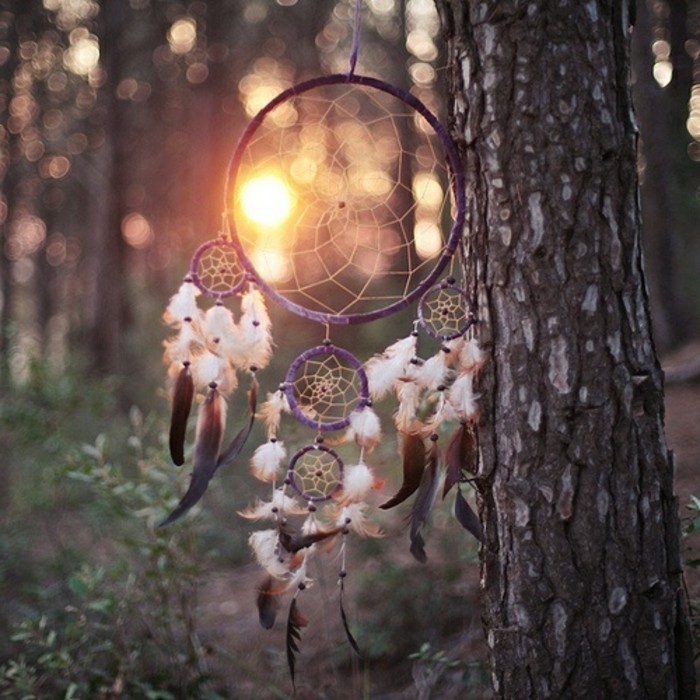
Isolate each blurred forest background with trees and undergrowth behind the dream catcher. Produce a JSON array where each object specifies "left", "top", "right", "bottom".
[{"left": 0, "top": 0, "right": 700, "bottom": 698}]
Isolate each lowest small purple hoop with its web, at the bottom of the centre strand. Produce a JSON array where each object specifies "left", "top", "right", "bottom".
[{"left": 287, "top": 443, "right": 344, "bottom": 502}]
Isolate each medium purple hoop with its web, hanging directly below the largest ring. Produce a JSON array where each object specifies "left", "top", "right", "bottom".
[{"left": 284, "top": 343, "right": 369, "bottom": 431}]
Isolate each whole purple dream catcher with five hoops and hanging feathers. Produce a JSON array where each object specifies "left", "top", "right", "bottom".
[{"left": 163, "top": 1, "right": 484, "bottom": 679}]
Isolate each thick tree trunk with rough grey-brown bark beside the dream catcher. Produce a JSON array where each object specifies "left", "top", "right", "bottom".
[{"left": 437, "top": 0, "right": 694, "bottom": 699}]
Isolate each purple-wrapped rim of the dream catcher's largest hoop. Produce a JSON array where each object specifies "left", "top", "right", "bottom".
[{"left": 224, "top": 73, "right": 466, "bottom": 325}]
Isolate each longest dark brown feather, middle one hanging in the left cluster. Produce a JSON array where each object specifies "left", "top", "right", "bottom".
[{"left": 158, "top": 387, "right": 224, "bottom": 527}]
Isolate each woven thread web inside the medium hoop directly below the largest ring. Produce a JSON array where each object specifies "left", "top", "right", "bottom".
[{"left": 292, "top": 354, "right": 362, "bottom": 424}]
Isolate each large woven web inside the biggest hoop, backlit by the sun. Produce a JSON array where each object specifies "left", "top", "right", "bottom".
[{"left": 233, "top": 84, "right": 452, "bottom": 315}]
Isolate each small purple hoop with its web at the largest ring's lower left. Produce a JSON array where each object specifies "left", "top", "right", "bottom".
[{"left": 190, "top": 238, "right": 248, "bottom": 299}]
